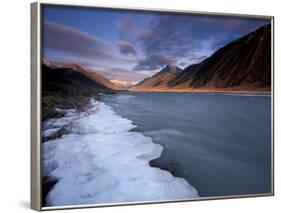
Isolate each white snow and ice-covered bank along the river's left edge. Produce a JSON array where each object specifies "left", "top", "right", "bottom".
[{"left": 42, "top": 101, "right": 198, "bottom": 206}]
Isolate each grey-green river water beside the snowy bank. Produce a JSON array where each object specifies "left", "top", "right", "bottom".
[{"left": 103, "top": 92, "right": 271, "bottom": 196}]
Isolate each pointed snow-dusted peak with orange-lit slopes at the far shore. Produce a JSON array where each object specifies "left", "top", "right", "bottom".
[{"left": 134, "top": 65, "right": 182, "bottom": 88}]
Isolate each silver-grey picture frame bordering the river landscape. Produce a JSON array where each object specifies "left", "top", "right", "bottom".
[{"left": 31, "top": 1, "right": 274, "bottom": 211}]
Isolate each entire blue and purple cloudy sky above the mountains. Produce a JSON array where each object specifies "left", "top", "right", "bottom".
[{"left": 42, "top": 5, "right": 270, "bottom": 82}]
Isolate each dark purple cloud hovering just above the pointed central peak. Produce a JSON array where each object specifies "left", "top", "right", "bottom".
[{"left": 133, "top": 53, "right": 178, "bottom": 70}]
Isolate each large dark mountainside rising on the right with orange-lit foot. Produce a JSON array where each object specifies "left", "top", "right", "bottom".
[{"left": 132, "top": 25, "right": 271, "bottom": 91}]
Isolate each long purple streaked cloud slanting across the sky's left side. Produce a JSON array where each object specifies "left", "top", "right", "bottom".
[{"left": 42, "top": 21, "right": 134, "bottom": 62}]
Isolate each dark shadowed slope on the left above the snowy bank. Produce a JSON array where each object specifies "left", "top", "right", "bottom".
[{"left": 42, "top": 63, "right": 113, "bottom": 121}]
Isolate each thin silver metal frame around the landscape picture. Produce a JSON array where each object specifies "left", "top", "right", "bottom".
[{"left": 30, "top": 1, "right": 275, "bottom": 211}]
